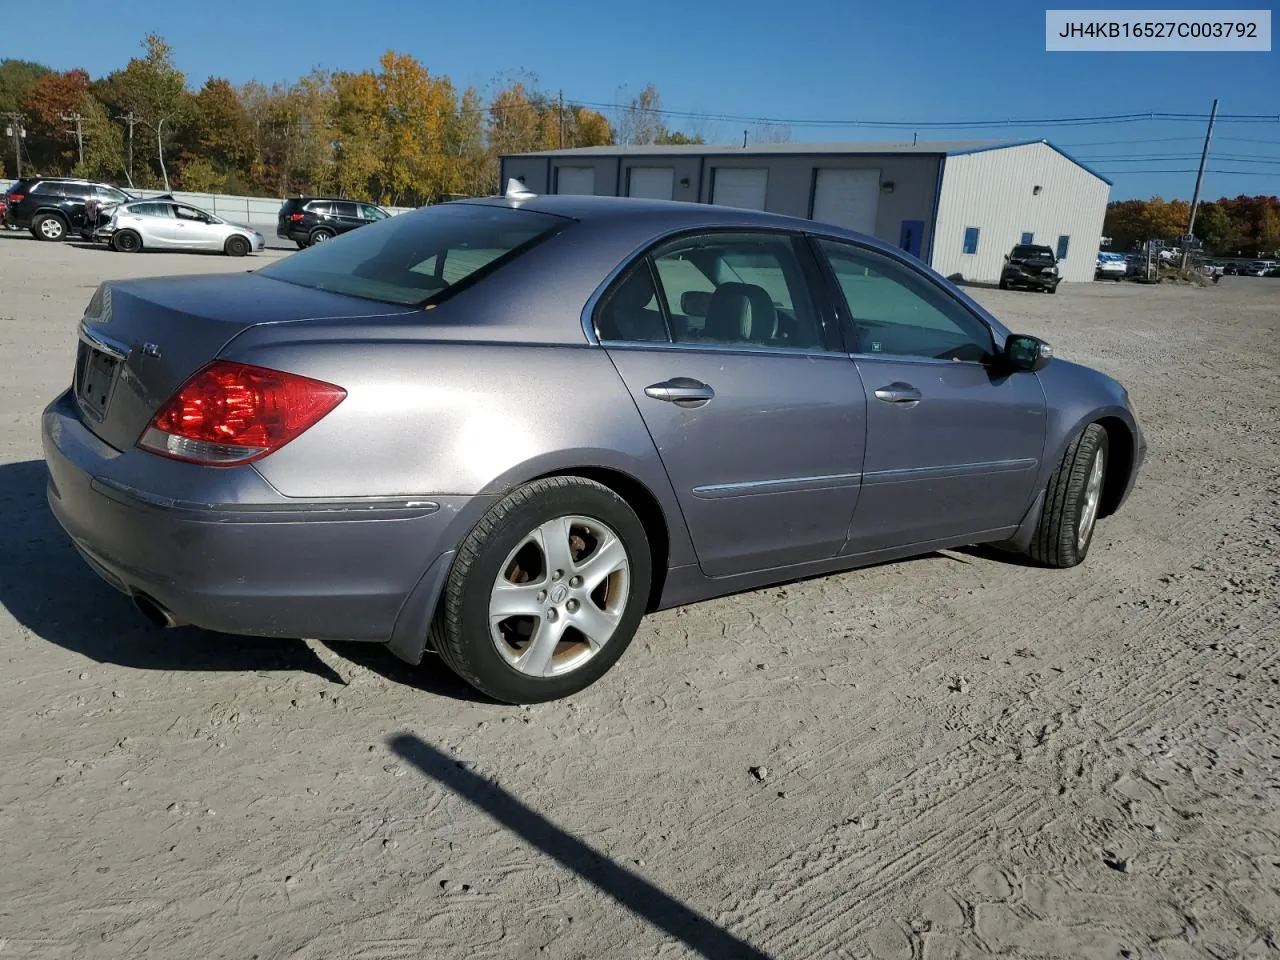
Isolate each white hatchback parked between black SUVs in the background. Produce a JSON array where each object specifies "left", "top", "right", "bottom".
[{"left": 93, "top": 198, "right": 266, "bottom": 257}]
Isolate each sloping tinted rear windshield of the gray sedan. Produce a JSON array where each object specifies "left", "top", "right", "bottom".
[{"left": 259, "top": 204, "right": 568, "bottom": 305}]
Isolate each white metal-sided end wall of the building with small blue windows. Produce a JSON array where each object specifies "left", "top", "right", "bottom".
[{"left": 929, "top": 143, "right": 1111, "bottom": 283}]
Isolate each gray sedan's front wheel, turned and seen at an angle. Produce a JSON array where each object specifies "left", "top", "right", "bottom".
[{"left": 1027, "top": 424, "right": 1110, "bottom": 567}]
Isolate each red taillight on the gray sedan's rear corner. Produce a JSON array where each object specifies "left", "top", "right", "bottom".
[{"left": 138, "top": 360, "right": 347, "bottom": 466}]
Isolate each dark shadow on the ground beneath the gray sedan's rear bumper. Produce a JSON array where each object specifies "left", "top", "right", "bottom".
[{"left": 0, "top": 460, "right": 475, "bottom": 699}]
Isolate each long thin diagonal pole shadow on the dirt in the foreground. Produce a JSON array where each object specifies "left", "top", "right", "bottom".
[{"left": 388, "top": 733, "right": 769, "bottom": 960}]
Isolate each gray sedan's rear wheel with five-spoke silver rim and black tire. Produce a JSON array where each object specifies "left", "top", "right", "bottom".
[{"left": 431, "top": 477, "right": 653, "bottom": 703}]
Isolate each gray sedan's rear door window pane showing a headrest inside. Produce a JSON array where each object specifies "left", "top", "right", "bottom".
[{"left": 653, "top": 233, "right": 826, "bottom": 349}]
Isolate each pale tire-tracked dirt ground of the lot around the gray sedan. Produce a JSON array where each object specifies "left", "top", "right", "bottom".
[{"left": 0, "top": 233, "right": 1280, "bottom": 960}]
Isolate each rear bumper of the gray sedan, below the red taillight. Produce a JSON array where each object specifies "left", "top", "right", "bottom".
[{"left": 42, "top": 390, "right": 476, "bottom": 641}]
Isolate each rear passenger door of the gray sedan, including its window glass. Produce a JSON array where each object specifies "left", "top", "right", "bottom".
[{"left": 595, "top": 233, "right": 867, "bottom": 576}]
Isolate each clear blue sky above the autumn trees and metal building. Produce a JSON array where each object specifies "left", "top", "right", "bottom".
[{"left": 12, "top": 0, "right": 1280, "bottom": 198}]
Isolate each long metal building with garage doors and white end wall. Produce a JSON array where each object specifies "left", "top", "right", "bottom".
[{"left": 500, "top": 140, "right": 1111, "bottom": 283}]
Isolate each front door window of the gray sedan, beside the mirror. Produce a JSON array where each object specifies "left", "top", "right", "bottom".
[{"left": 818, "top": 239, "right": 995, "bottom": 364}]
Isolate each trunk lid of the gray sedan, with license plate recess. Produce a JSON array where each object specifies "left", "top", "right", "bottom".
[{"left": 72, "top": 273, "right": 413, "bottom": 449}]
